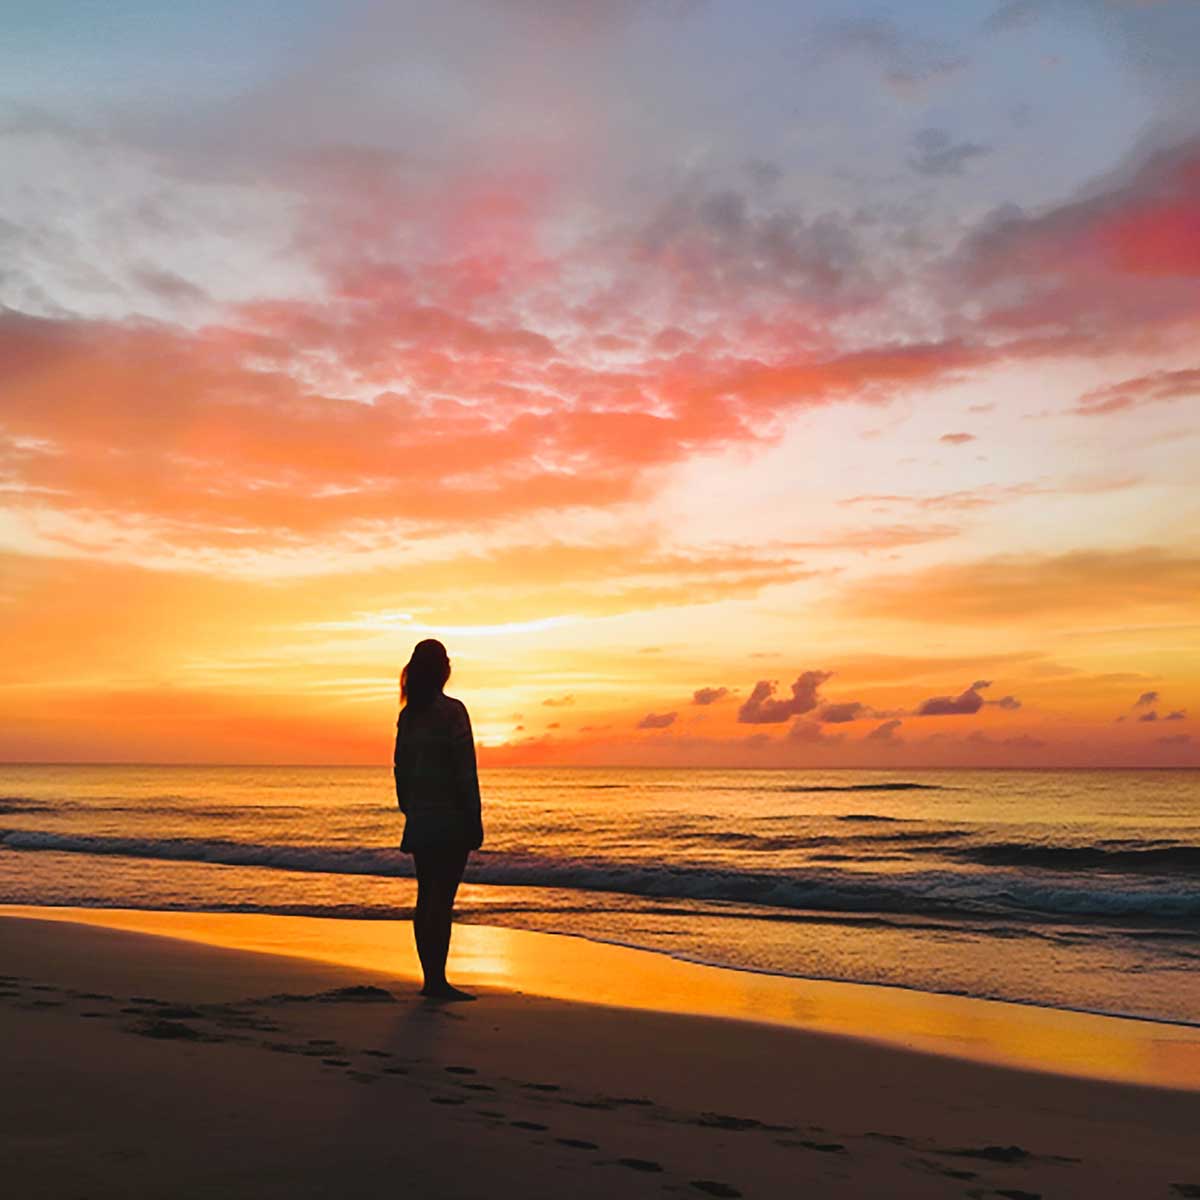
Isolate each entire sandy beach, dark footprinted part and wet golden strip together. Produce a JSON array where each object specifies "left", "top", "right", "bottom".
[{"left": 0, "top": 908, "right": 1200, "bottom": 1200}]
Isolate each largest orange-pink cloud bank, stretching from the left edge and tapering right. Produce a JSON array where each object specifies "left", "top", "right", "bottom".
[{"left": 0, "top": 300, "right": 993, "bottom": 566}]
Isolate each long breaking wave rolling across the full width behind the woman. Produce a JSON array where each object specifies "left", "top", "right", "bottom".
[{"left": 0, "top": 829, "right": 1200, "bottom": 923}]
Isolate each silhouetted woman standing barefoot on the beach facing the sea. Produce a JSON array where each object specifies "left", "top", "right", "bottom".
[{"left": 394, "top": 638, "right": 484, "bottom": 1000}]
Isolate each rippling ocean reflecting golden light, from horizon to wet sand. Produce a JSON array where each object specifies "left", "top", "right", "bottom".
[{"left": 0, "top": 766, "right": 1200, "bottom": 1024}]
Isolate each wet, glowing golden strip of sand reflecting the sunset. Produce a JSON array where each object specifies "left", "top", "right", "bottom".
[{"left": 9, "top": 905, "right": 1200, "bottom": 1092}]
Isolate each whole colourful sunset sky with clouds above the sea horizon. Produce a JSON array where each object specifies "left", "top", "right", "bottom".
[{"left": 0, "top": 0, "right": 1200, "bottom": 768}]
